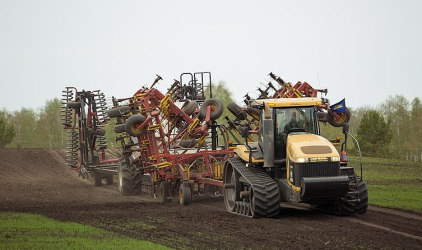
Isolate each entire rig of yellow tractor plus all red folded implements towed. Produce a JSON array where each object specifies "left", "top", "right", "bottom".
[{"left": 62, "top": 72, "right": 368, "bottom": 218}]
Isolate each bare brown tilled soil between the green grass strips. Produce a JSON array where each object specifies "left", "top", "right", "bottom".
[{"left": 0, "top": 149, "right": 422, "bottom": 249}]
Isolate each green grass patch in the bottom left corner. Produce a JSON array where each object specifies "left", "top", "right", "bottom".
[{"left": 0, "top": 212, "right": 170, "bottom": 249}]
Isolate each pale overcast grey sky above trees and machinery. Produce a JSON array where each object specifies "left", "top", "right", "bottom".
[{"left": 0, "top": 0, "right": 422, "bottom": 111}]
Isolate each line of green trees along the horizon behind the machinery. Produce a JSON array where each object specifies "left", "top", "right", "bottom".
[{"left": 0, "top": 86, "right": 422, "bottom": 161}]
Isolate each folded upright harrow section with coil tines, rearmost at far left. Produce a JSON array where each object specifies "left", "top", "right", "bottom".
[{"left": 61, "top": 87, "right": 117, "bottom": 186}]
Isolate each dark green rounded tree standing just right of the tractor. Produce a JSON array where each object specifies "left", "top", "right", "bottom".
[{"left": 357, "top": 110, "right": 393, "bottom": 157}]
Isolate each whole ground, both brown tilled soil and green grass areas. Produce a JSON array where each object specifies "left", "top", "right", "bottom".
[{"left": 0, "top": 149, "right": 422, "bottom": 249}]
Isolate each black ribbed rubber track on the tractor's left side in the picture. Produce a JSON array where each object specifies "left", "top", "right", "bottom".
[{"left": 229, "top": 158, "right": 280, "bottom": 218}]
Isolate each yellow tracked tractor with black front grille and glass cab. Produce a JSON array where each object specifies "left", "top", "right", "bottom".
[{"left": 223, "top": 97, "right": 368, "bottom": 218}]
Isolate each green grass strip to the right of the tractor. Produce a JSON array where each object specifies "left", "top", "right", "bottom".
[{"left": 349, "top": 157, "right": 422, "bottom": 212}]
